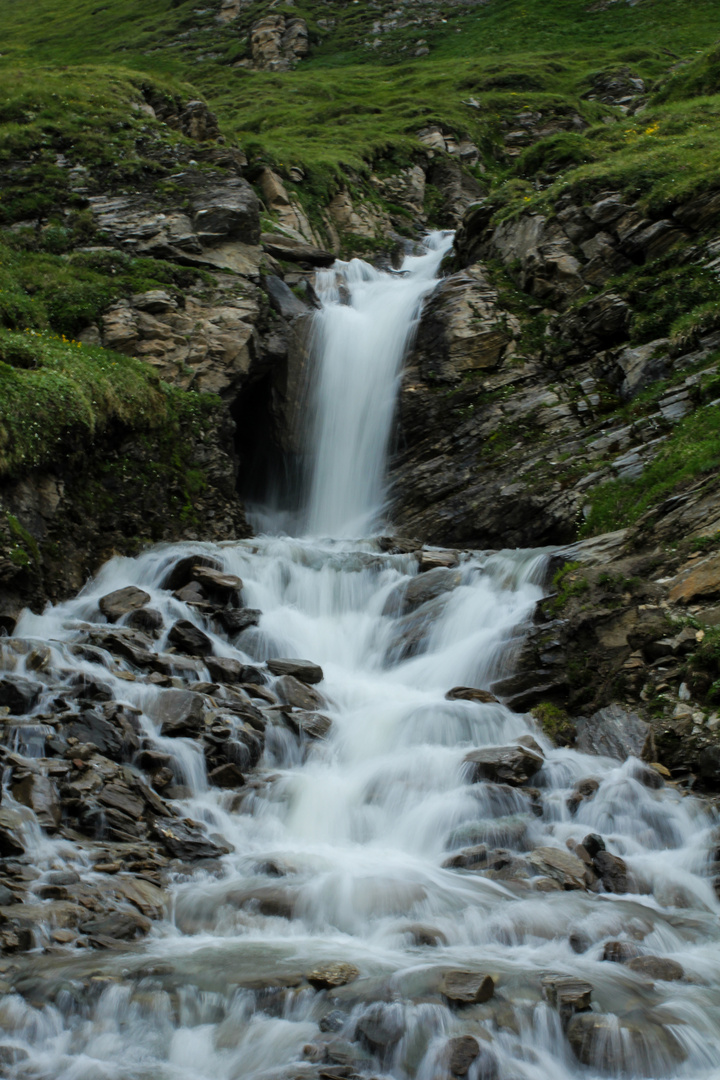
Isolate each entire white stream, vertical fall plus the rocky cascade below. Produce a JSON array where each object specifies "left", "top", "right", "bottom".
[{"left": 0, "top": 238, "right": 720, "bottom": 1080}]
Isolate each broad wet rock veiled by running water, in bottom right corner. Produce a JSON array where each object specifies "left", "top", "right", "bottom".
[{"left": 567, "top": 1012, "right": 687, "bottom": 1078}]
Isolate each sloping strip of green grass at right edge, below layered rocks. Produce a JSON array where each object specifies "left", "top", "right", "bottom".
[{"left": 580, "top": 405, "right": 720, "bottom": 538}]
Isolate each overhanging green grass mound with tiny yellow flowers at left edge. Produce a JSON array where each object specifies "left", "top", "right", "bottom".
[{"left": 0, "top": 330, "right": 217, "bottom": 477}]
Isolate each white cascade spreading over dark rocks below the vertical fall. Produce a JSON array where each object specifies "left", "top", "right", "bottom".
[{"left": 0, "top": 238, "right": 720, "bottom": 1080}]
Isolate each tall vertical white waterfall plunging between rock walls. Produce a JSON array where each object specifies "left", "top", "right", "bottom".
[{"left": 307, "top": 232, "right": 452, "bottom": 537}]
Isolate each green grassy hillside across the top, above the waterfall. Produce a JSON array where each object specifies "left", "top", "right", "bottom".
[{"left": 0, "top": 0, "right": 720, "bottom": 530}]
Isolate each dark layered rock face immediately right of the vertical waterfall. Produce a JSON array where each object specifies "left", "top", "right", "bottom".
[{"left": 393, "top": 184, "right": 720, "bottom": 546}]
